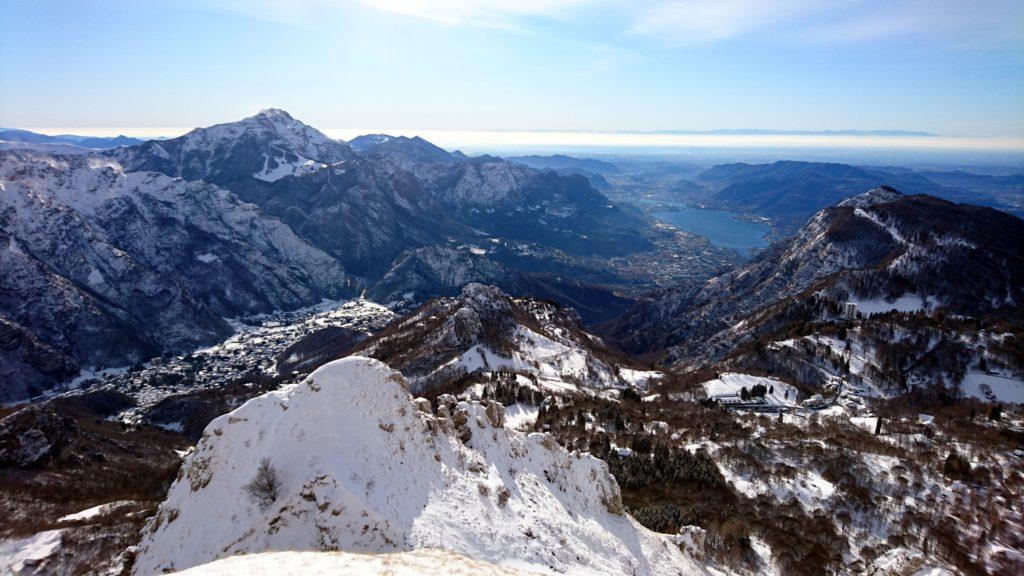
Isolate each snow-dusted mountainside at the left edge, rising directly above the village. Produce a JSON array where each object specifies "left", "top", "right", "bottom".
[{"left": 0, "top": 147, "right": 354, "bottom": 399}]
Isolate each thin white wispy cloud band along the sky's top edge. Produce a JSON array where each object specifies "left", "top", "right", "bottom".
[{"left": 189, "top": 0, "right": 1024, "bottom": 49}]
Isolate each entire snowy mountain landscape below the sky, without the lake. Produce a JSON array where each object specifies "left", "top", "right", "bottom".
[{"left": 0, "top": 110, "right": 1024, "bottom": 576}]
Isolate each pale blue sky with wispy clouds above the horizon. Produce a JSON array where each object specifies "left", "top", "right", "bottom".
[{"left": 0, "top": 0, "right": 1024, "bottom": 138}]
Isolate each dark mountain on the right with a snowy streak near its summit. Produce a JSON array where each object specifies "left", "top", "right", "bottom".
[{"left": 609, "top": 188, "right": 1024, "bottom": 363}]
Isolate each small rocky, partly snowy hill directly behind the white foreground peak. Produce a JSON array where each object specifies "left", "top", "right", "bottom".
[{"left": 354, "top": 284, "right": 651, "bottom": 394}]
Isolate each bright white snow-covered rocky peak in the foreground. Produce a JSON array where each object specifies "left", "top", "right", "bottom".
[{"left": 134, "top": 357, "right": 703, "bottom": 575}]
